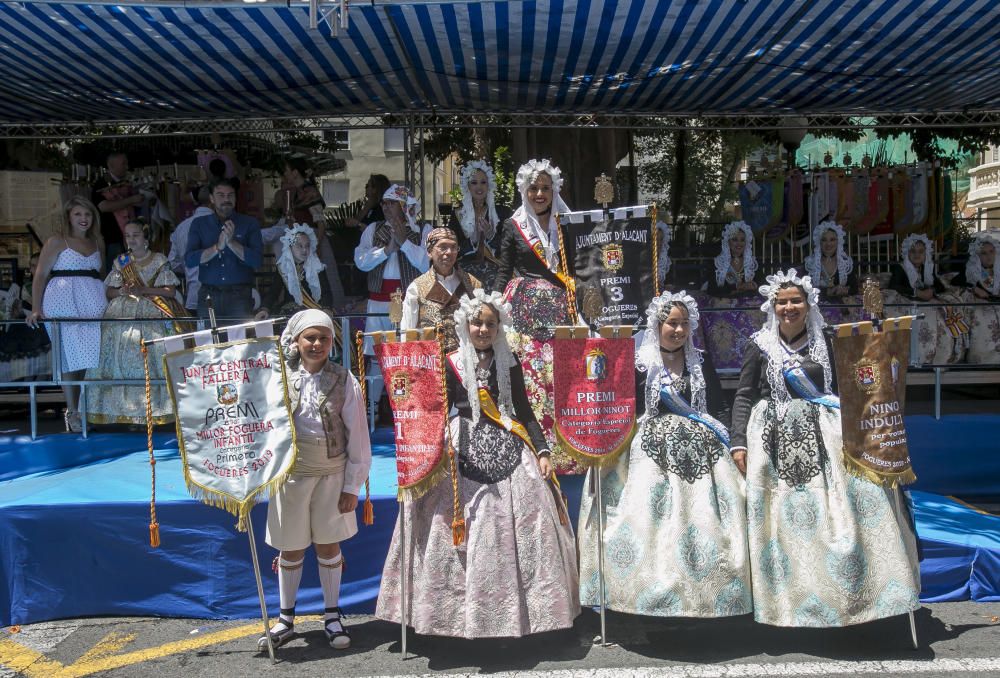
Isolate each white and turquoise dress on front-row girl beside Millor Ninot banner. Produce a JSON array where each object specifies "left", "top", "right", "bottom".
[{"left": 579, "top": 354, "right": 752, "bottom": 617}]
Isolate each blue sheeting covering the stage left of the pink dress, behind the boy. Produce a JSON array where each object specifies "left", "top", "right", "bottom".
[{"left": 0, "top": 430, "right": 583, "bottom": 626}]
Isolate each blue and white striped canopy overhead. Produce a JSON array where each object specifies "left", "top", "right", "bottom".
[{"left": 0, "top": 0, "right": 1000, "bottom": 123}]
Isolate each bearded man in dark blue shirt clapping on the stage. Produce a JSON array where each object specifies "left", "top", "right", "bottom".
[{"left": 184, "top": 178, "right": 264, "bottom": 320}]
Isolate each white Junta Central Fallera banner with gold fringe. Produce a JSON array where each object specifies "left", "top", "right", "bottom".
[{"left": 163, "top": 337, "right": 295, "bottom": 531}]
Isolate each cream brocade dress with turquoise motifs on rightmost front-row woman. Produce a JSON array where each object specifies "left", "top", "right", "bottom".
[{"left": 731, "top": 342, "right": 920, "bottom": 627}]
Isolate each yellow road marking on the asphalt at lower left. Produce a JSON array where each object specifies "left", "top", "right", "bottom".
[{"left": 0, "top": 615, "right": 321, "bottom": 678}]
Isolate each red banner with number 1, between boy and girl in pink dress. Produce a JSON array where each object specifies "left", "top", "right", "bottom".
[{"left": 375, "top": 341, "right": 447, "bottom": 501}]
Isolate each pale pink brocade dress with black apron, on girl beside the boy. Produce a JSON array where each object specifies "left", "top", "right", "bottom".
[{"left": 375, "top": 353, "right": 580, "bottom": 638}]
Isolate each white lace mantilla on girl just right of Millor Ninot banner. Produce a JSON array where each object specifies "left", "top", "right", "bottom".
[{"left": 635, "top": 290, "right": 707, "bottom": 417}]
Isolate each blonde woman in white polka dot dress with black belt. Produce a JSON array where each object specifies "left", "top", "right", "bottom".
[{"left": 27, "top": 197, "right": 108, "bottom": 431}]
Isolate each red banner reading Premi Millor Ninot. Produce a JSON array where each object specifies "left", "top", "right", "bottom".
[{"left": 553, "top": 337, "right": 635, "bottom": 466}]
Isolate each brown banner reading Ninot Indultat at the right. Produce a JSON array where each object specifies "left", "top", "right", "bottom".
[{"left": 833, "top": 316, "right": 917, "bottom": 487}]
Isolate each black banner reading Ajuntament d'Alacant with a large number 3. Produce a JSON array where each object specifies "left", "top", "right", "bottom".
[{"left": 559, "top": 206, "right": 656, "bottom": 327}]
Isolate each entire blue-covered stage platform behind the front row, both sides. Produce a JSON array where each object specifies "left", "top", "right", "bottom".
[{"left": 0, "top": 415, "right": 1000, "bottom": 626}]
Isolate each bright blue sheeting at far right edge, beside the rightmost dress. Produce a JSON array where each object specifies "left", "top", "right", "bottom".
[{"left": 912, "top": 492, "right": 1000, "bottom": 603}]
